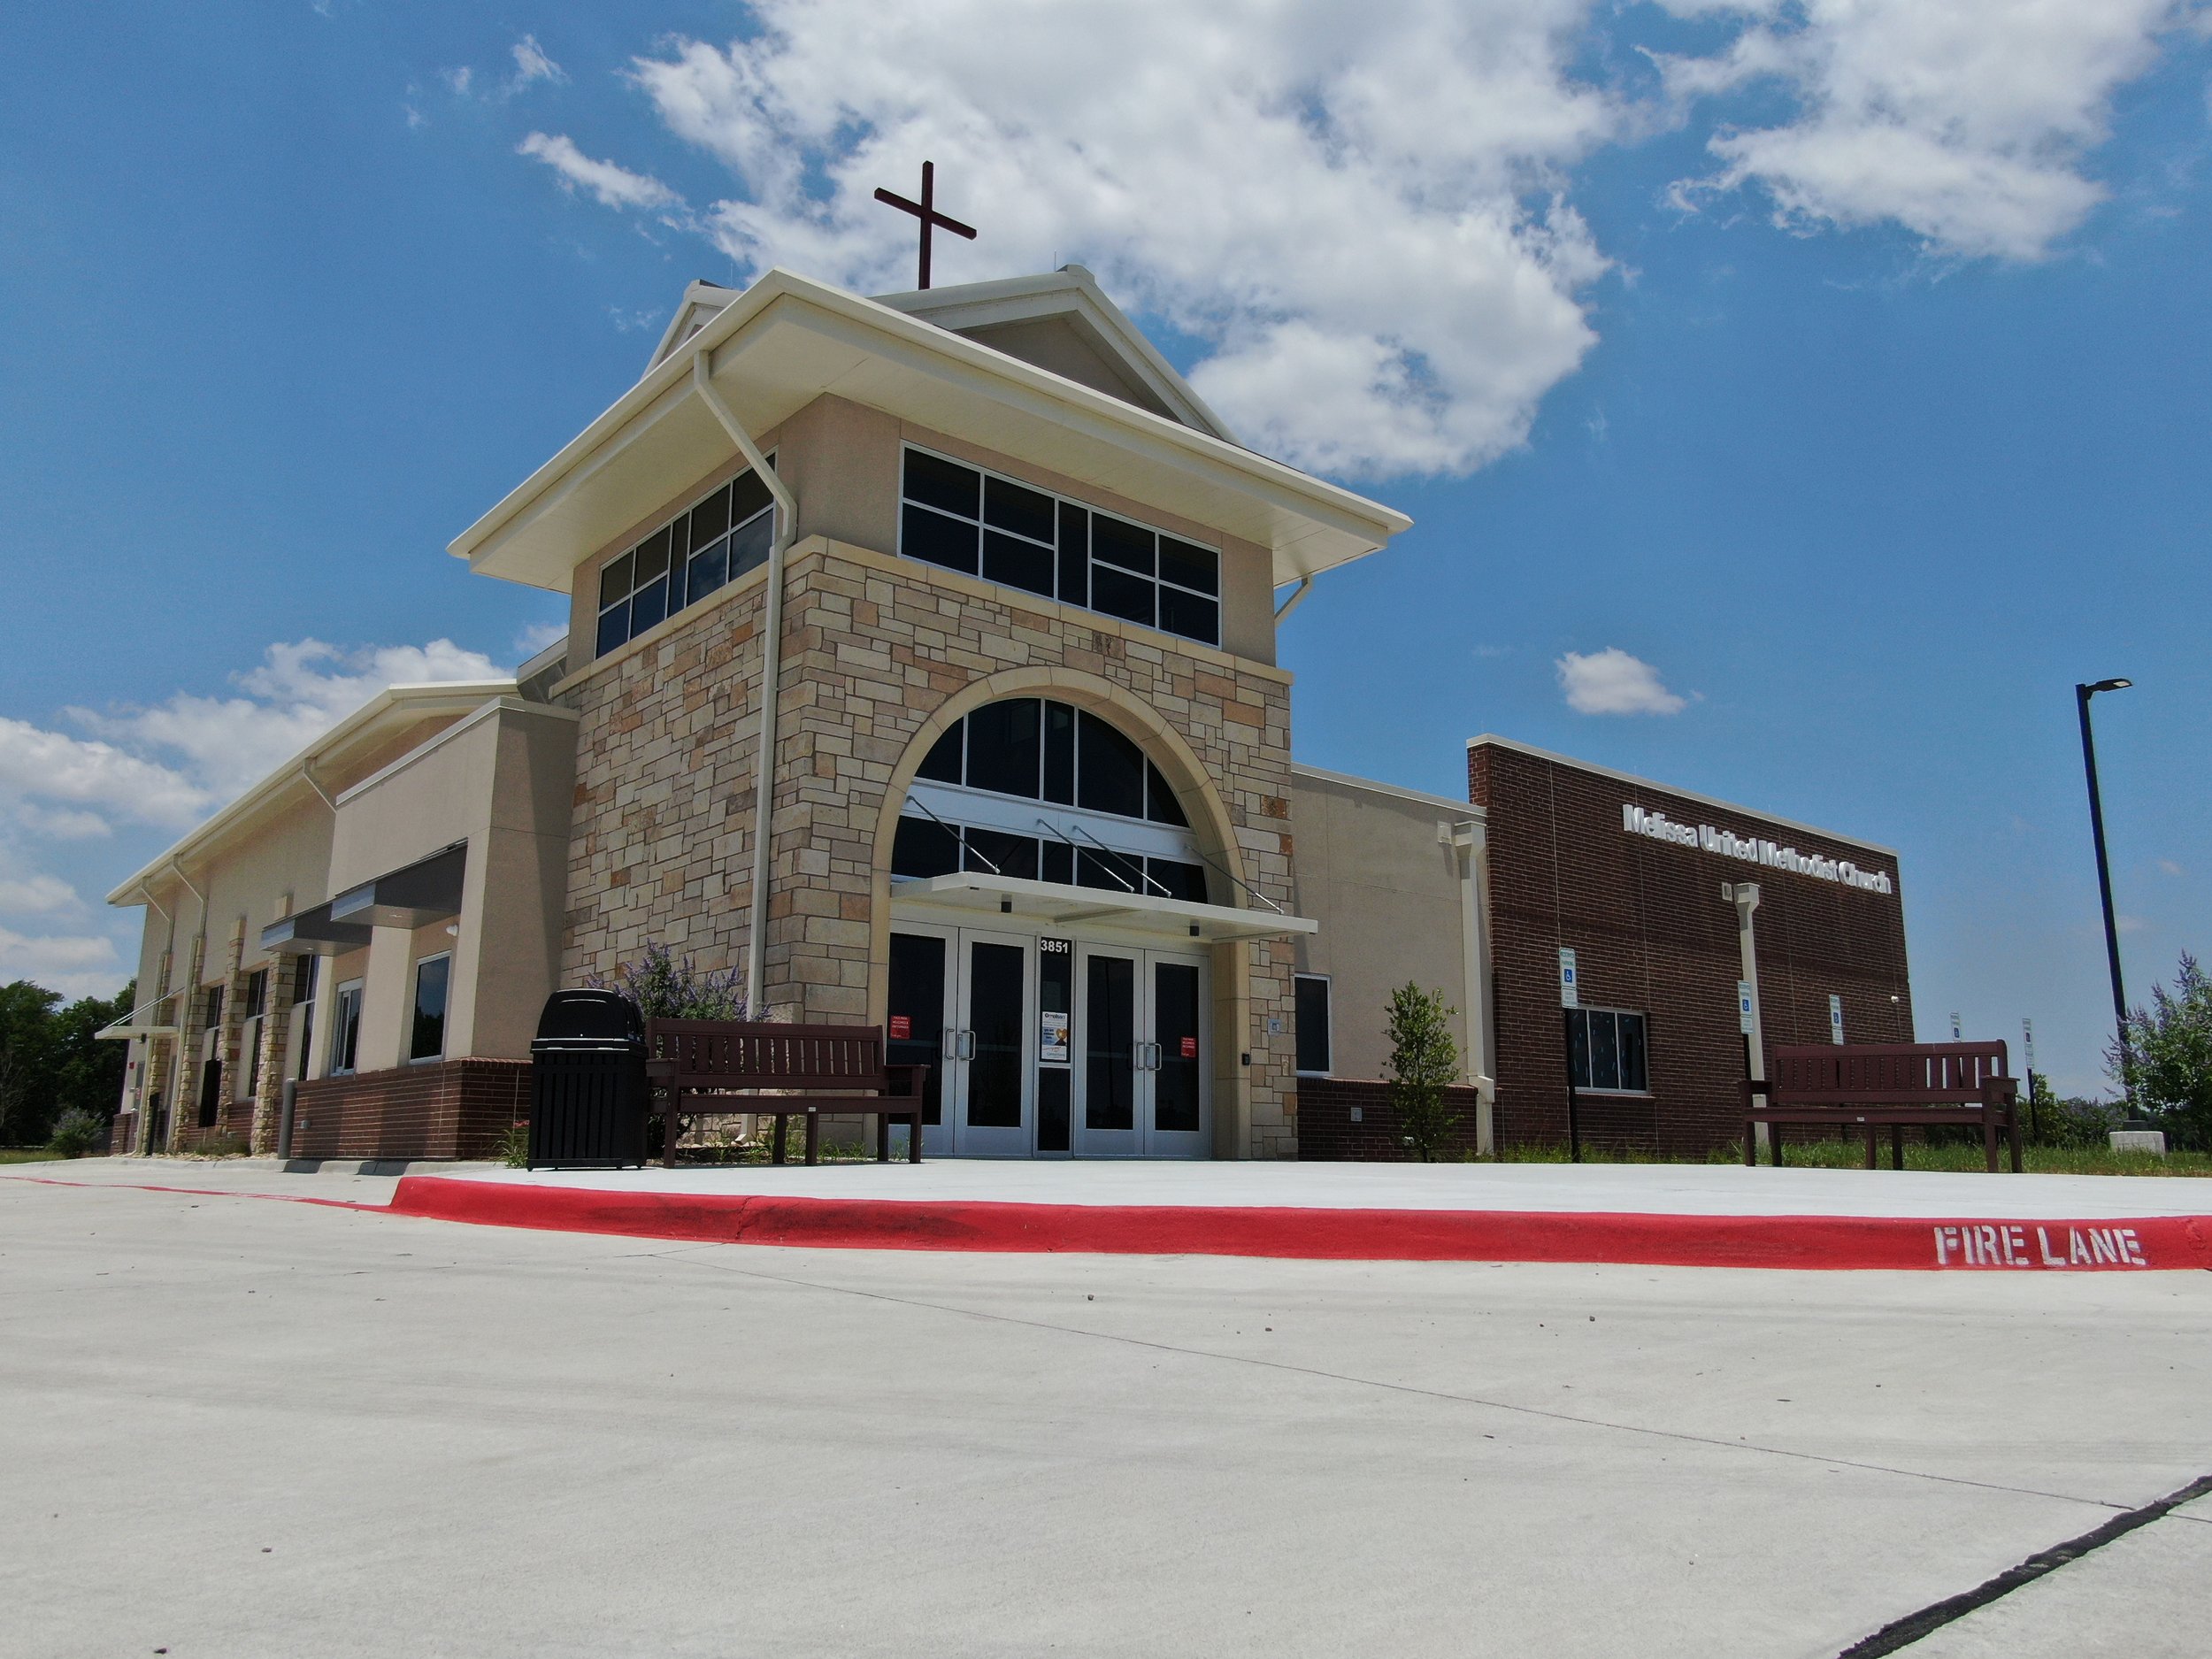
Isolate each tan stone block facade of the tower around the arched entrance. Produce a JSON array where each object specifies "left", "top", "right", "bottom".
[{"left": 562, "top": 535, "right": 1296, "bottom": 1157}]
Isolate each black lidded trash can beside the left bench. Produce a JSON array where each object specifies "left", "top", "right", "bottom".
[{"left": 531, "top": 991, "right": 646, "bottom": 1171}]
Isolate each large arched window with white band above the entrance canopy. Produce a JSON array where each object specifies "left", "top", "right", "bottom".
[{"left": 892, "top": 697, "right": 1208, "bottom": 905}]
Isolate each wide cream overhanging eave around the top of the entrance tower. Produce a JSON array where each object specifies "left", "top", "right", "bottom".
[{"left": 449, "top": 268, "right": 1411, "bottom": 593}]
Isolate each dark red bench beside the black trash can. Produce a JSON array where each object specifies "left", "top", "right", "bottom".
[{"left": 646, "top": 1020, "right": 929, "bottom": 1168}]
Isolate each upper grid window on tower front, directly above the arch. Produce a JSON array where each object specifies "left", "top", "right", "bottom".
[{"left": 898, "top": 449, "right": 1221, "bottom": 646}]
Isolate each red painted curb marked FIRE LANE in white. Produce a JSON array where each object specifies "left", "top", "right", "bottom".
[{"left": 392, "top": 1175, "right": 2212, "bottom": 1272}]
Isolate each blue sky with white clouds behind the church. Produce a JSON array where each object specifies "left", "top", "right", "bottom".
[{"left": 0, "top": 0, "right": 2212, "bottom": 1106}]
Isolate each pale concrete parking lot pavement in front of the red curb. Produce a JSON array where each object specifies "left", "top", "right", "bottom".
[{"left": 0, "top": 1177, "right": 2212, "bottom": 1659}]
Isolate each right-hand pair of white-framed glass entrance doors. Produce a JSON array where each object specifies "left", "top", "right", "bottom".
[{"left": 1075, "top": 945, "right": 1212, "bottom": 1157}]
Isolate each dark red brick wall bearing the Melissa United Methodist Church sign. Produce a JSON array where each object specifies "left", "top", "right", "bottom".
[{"left": 1467, "top": 746, "right": 1914, "bottom": 1157}]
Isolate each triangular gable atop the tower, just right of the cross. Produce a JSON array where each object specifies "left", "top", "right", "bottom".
[{"left": 876, "top": 265, "right": 1237, "bottom": 442}]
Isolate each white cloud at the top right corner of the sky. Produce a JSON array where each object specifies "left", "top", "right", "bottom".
[{"left": 1657, "top": 0, "right": 2185, "bottom": 259}]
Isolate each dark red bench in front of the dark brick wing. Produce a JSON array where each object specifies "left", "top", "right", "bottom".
[{"left": 1743, "top": 1042, "right": 2020, "bottom": 1175}]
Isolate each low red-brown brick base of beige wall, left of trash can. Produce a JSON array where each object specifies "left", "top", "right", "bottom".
[{"left": 292, "top": 1060, "right": 531, "bottom": 1159}]
